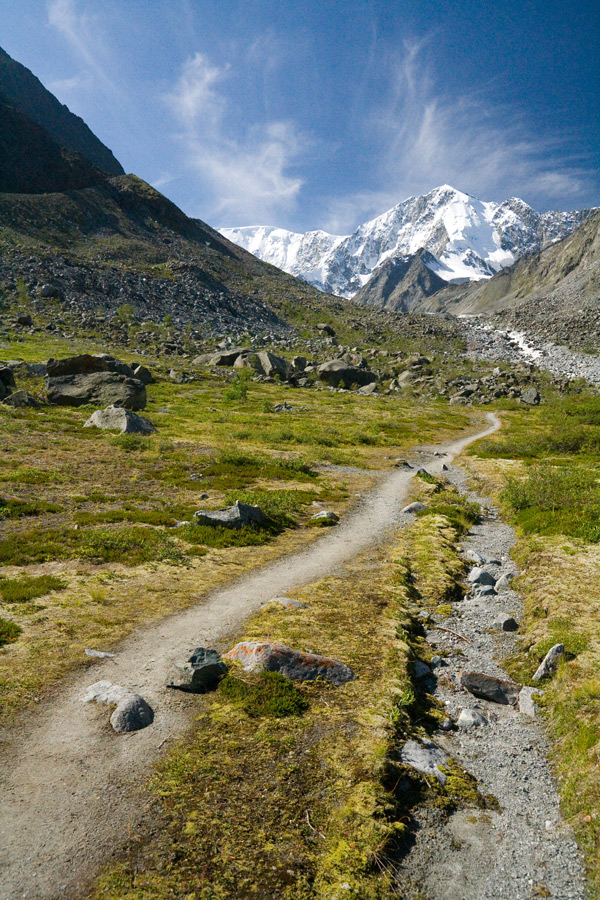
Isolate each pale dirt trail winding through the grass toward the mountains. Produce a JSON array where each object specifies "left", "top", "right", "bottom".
[{"left": 0, "top": 413, "right": 500, "bottom": 900}]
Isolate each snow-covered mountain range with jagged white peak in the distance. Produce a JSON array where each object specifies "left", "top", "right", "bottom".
[{"left": 221, "top": 184, "right": 589, "bottom": 297}]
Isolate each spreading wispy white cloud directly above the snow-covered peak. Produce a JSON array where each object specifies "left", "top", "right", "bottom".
[{"left": 325, "top": 37, "right": 592, "bottom": 232}]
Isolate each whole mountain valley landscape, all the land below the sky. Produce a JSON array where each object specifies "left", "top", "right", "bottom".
[{"left": 0, "top": 42, "right": 600, "bottom": 900}]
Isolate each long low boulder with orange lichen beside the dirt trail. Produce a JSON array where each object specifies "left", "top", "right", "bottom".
[{"left": 225, "top": 641, "right": 355, "bottom": 685}]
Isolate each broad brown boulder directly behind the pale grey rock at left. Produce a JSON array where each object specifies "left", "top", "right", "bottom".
[{"left": 46, "top": 372, "right": 146, "bottom": 409}]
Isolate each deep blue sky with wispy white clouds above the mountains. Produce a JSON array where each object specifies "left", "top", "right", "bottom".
[{"left": 0, "top": 0, "right": 600, "bottom": 234}]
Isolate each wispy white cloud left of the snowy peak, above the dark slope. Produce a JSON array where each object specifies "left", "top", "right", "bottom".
[{"left": 167, "top": 53, "right": 308, "bottom": 224}]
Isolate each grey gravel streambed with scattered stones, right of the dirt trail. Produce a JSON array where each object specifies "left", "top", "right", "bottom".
[{"left": 399, "top": 466, "right": 587, "bottom": 900}]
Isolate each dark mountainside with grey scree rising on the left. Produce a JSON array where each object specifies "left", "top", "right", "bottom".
[{"left": 0, "top": 54, "right": 356, "bottom": 335}]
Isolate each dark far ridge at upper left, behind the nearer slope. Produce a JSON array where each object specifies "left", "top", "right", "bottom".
[{"left": 0, "top": 47, "right": 125, "bottom": 175}]
